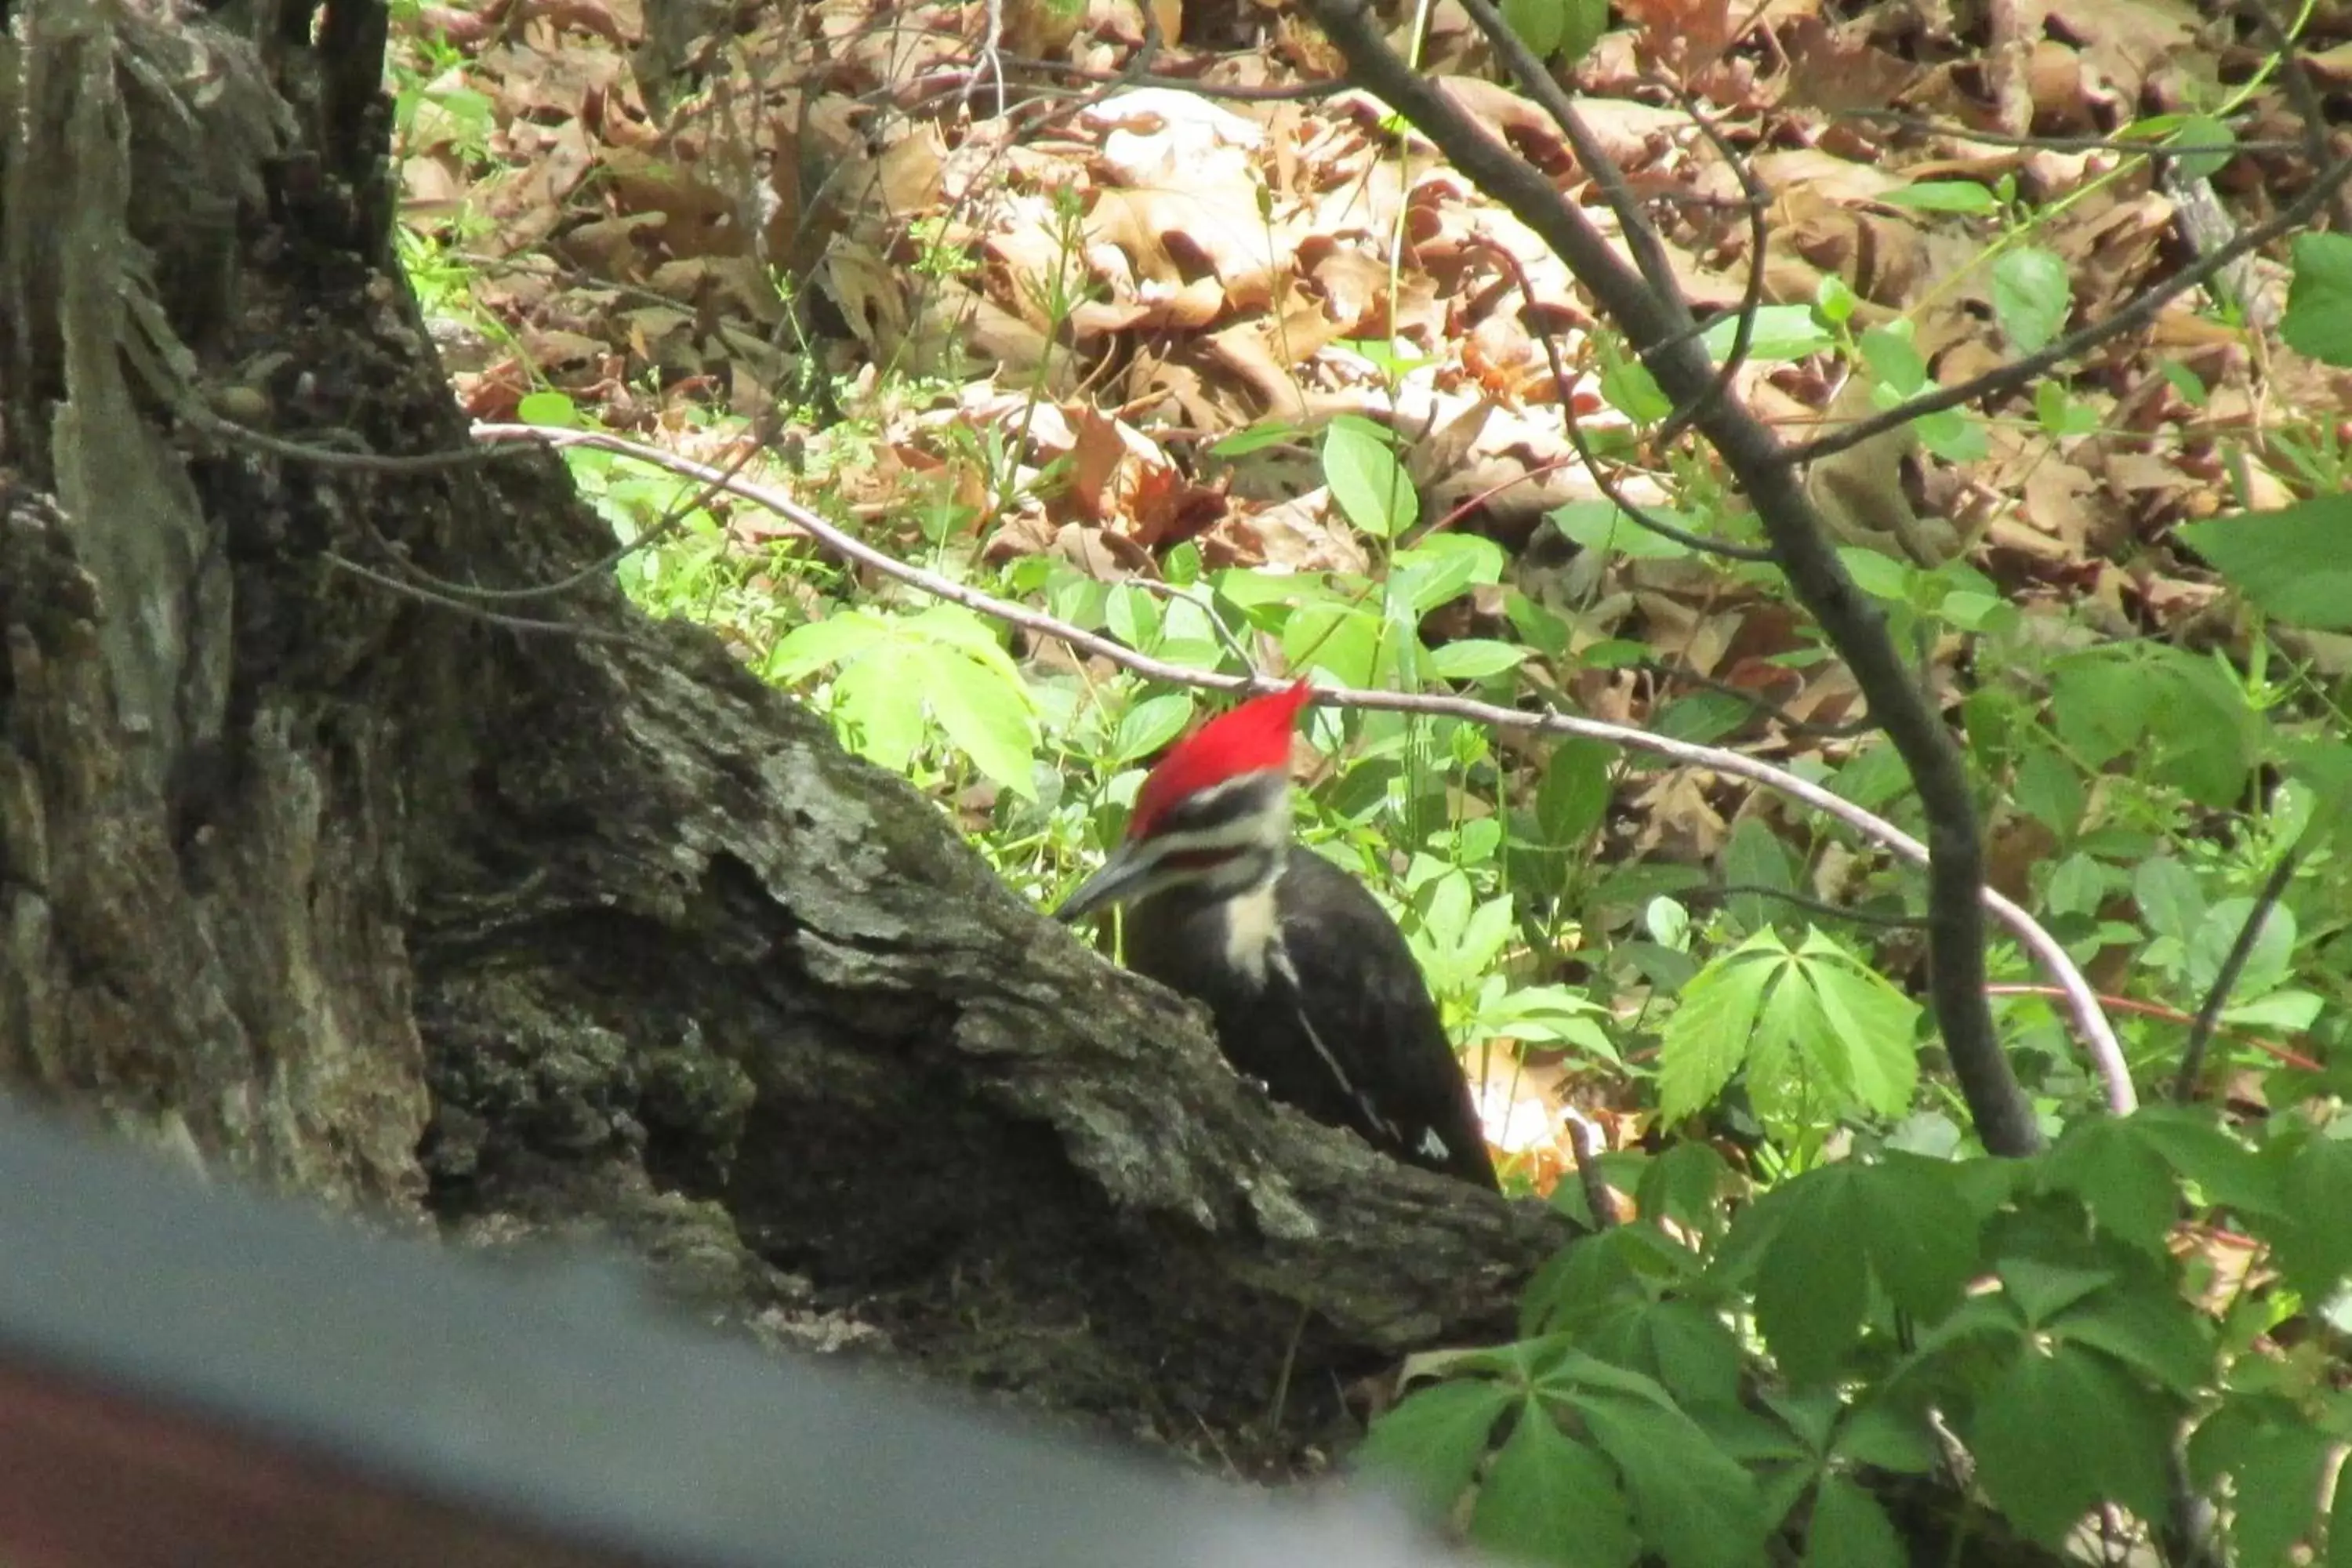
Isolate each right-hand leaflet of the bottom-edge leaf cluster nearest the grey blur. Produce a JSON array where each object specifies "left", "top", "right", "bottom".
[{"left": 1569, "top": 1394, "right": 1764, "bottom": 1568}]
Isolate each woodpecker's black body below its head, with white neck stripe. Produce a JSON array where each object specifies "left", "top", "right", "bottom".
[{"left": 1127, "top": 846, "right": 1496, "bottom": 1189}]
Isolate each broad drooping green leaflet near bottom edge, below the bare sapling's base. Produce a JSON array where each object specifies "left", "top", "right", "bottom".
[{"left": 1966, "top": 1345, "right": 2171, "bottom": 1547}]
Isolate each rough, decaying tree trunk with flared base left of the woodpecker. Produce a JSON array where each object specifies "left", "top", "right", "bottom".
[{"left": 0, "top": 0, "right": 1559, "bottom": 1469}]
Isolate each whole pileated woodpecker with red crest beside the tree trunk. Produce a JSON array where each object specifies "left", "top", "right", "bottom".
[{"left": 1054, "top": 682, "right": 1496, "bottom": 1189}]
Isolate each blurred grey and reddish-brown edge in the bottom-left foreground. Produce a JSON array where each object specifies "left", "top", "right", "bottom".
[{"left": 0, "top": 1105, "right": 1468, "bottom": 1568}]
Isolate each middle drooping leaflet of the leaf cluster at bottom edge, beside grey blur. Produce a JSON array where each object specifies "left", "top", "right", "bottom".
[{"left": 1470, "top": 1406, "right": 1642, "bottom": 1568}]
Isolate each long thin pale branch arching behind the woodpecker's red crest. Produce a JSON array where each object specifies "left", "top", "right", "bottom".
[{"left": 473, "top": 426, "right": 2138, "bottom": 1114}]
